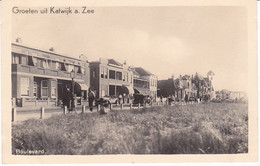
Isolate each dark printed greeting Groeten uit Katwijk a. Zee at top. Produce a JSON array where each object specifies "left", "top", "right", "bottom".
[{"left": 12, "top": 6, "right": 95, "bottom": 15}]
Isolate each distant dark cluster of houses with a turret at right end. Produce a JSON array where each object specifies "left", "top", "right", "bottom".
[{"left": 158, "top": 71, "right": 215, "bottom": 101}]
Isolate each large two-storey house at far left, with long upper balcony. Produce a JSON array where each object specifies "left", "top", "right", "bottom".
[{"left": 11, "top": 42, "right": 90, "bottom": 107}]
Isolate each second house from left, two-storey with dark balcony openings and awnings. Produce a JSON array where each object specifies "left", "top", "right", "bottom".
[{"left": 90, "top": 59, "right": 134, "bottom": 98}]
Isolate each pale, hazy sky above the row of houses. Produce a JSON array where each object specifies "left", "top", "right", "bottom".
[{"left": 12, "top": 6, "right": 248, "bottom": 91}]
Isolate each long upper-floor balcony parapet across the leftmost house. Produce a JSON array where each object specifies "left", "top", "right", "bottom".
[{"left": 12, "top": 64, "right": 86, "bottom": 79}]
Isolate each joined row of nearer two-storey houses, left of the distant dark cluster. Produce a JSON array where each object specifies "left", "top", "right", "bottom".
[{"left": 12, "top": 39, "right": 157, "bottom": 107}]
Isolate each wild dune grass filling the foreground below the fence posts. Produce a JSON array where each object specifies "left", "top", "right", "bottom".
[{"left": 12, "top": 103, "right": 248, "bottom": 155}]
